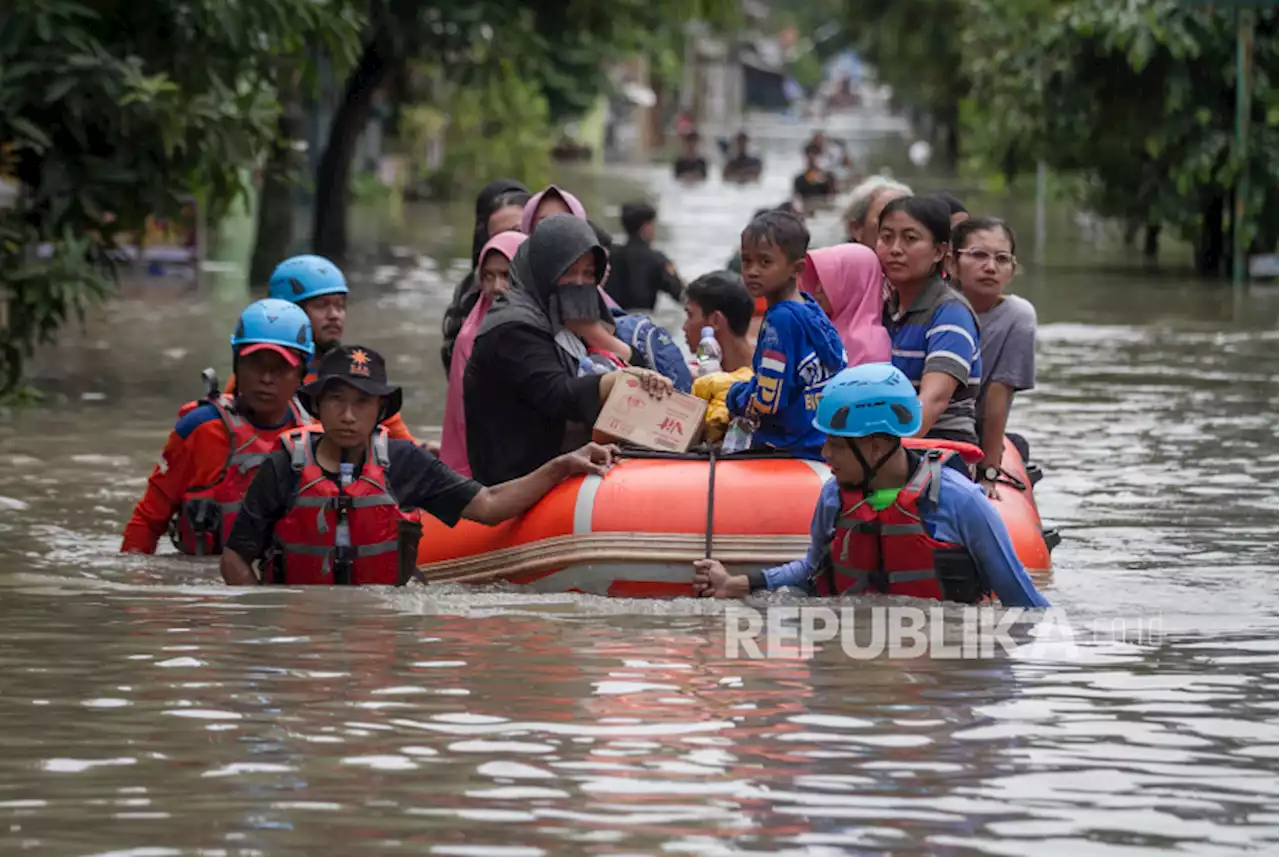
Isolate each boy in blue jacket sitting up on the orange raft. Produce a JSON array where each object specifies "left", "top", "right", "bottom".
[{"left": 727, "top": 211, "right": 846, "bottom": 460}]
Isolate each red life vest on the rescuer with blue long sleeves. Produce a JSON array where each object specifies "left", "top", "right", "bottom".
[{"left": 815, "top": 449, "right": 991, "bottom": 604}]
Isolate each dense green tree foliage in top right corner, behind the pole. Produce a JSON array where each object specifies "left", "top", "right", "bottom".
[{"left": 957, "top": 0, "right": 1280, "bottom": 271}]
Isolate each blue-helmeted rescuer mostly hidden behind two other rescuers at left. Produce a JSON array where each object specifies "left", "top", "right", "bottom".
[{"left": 227, "top": 255, "right": 424, "bottom": 442}]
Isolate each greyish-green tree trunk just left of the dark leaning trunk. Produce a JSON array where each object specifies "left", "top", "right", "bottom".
[{"left": 248, "top": 93, "right": 302, "bottom": 289}]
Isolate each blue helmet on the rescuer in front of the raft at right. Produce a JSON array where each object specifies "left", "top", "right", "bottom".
[{"left": 813, "top": 363, "right": 922, "bottom": 437}]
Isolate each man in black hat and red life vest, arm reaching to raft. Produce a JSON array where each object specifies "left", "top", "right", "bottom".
[{"left": 221, "top": 345, "right": 617, "bottom": 586}]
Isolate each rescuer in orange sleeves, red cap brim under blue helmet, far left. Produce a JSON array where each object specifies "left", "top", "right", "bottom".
[{"left": 120, "top": 298, "right": 315, "bottom": 555}]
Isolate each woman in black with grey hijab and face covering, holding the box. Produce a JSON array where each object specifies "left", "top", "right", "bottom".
[{"left": 462, "top": 215, "right": 671, "bottom": 485}]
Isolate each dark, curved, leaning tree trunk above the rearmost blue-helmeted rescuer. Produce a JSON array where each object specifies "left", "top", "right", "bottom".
[{"left": 311, "top": 28, "right": 397, "bottom": 260}]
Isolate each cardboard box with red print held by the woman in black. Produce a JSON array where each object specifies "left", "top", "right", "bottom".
[{"left": 595, "top": 375, "right": 707, "bottom": 453}]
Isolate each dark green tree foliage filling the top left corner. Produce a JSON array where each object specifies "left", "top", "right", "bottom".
[{"left": 0, "top": 0, "right": 357, "bottom": 390}]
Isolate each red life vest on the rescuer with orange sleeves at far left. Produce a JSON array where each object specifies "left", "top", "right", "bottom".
[{"left": 169, "top": 393, "right": 312, "bottom": 556}]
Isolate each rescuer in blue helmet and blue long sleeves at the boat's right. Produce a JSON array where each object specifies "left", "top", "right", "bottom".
[{"left": 694, "top": 363, "right": 1048, "bottom": 608}]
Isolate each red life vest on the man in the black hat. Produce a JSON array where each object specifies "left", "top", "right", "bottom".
[{"left": 264, "top": 426, "right": 422, "bottom": 586}]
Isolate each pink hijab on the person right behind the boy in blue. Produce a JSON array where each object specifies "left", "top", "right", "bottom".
[{"left": 800, "top": 244, "right": 892, "bottom": 366}]
